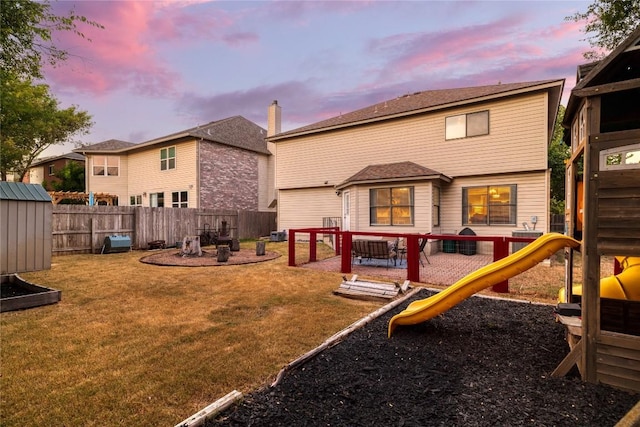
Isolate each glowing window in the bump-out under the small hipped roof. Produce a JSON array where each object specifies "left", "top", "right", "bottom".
[{"left": 369, "top": 187, "right": 413, "bottom": 225}]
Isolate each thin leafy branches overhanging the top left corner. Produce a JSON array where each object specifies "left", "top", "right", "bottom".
[{"left": 0, "top": 0, "right": 104, "bottom": 78}]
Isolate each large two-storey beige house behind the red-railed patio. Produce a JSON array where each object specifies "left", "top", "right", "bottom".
[{"left": 267, "top": 80, "right": 564, "bottom": 242}]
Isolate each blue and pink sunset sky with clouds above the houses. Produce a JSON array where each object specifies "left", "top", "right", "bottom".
[{"left": 44, "top": 0, "right": 591, "bottom": 155}]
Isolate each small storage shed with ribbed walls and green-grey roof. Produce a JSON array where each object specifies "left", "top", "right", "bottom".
[{"left": 0, "top": 181, "right": 53, "bottom": 275}]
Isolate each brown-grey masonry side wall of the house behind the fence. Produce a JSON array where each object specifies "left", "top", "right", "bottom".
[{"left": 199, "top": 141, "right": 259, "bottom": 211}]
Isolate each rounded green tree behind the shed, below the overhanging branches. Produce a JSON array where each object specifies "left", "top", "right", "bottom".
[{"left": 0, "top": 74, "right": 92, "bottom": 181}]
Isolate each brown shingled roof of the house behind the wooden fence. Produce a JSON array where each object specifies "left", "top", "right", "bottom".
[{"left": 74, "top": 116, "right": 271, "bottom": 154}]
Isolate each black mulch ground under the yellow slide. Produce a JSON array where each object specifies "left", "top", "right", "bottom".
[{"left": 206, "top": 291, "right": 639, "bottom": 427}]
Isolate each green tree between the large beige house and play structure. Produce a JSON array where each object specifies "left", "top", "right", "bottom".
[{"left": 547, "top": 105, "right": 571, "bottom": 213}]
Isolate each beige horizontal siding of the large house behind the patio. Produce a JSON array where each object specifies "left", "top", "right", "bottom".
[{"left": 276, "top": 92, "right": 549, "bottom": 236}]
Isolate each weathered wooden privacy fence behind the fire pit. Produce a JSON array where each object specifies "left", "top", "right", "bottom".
[{"left": 51, "top": 205, "right": 276, "bottom": 255}]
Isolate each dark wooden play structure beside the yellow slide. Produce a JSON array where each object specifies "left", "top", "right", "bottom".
[{"left": 554, "top": 27, "right": 640, "bottom": 392}]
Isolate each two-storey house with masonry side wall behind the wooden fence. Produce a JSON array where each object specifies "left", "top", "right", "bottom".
[{"left": 76, "top": 116, "right": 274, "bottom": 211}]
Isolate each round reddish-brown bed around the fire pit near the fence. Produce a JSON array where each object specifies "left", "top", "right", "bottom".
[{"left": 140, "top": 247, "right": 281, "bottom": 267}]
